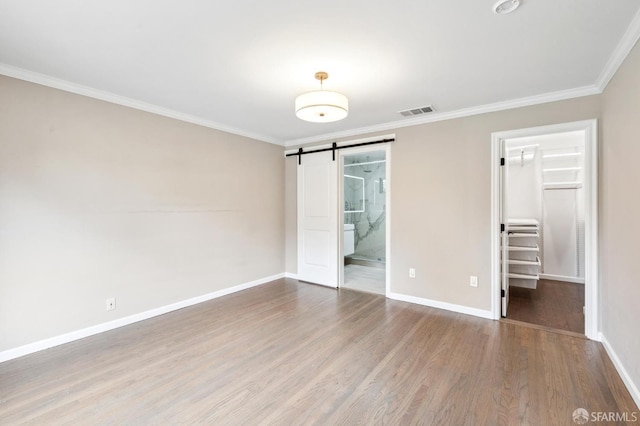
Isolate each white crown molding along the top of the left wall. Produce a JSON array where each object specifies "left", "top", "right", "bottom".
[{"left": 0, "top": 63, "right": 283, "bottom": 146}]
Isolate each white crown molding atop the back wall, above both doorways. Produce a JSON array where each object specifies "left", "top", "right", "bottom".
[{"left": 284, "top": 85, "right": 601, "bottom": 148}]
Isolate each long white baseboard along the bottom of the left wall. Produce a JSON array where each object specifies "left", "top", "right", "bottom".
[{"left": 0, "top": 273, "right": 285, "bottom": 362}]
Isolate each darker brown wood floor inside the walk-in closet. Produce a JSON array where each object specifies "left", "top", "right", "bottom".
[{"left": 507, "top": 280, "right": 584, "bottom": 334}]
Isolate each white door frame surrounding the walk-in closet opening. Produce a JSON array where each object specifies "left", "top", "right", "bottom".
[{"left": 491, "top": 119, "right": 600, "bottom": 341}]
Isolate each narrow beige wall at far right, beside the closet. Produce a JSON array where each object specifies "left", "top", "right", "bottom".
[{"left": 600, "top": 40, "right": 640, "bottom": 387}]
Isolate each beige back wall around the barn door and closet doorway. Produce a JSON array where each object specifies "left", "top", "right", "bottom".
[{"left": 286, "top": 96, "right": 600, "bottom": 311}]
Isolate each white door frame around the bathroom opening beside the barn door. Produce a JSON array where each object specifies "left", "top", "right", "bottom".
[{"left": 338, "top": 140, "right": 395, "bottom": 297}]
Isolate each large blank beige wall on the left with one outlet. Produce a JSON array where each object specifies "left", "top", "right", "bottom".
[{"left": 0, "top": 77, "right": 285, "bottom": 351}]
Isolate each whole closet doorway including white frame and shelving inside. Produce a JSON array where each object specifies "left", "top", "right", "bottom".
[{"left": 494, "top": 121, "right": 597, "bottom": 338}]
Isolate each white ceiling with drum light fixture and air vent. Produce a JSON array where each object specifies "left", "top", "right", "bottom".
[{"left": 0, "top": 0, "right": 640, "bottom": 145}]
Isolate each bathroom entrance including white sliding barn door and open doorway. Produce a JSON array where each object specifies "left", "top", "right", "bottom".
[{"left": 296, "top": 135, "right": 395, "bottom": 295}]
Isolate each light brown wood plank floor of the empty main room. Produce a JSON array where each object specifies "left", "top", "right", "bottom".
[{"left": 0, "top": 280, "right": 638, "bottom": 425}]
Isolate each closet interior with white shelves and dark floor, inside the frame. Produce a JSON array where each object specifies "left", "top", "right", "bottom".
[{"left": 503, "top": 131, "right": 585, "bottom": 333}]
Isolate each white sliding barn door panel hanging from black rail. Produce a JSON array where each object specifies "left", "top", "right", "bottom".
[{"left": 297, "top": 151, "right": 339, "bottom": 287}]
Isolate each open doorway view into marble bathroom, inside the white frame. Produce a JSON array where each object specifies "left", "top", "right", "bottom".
[{"left": 340, "top": 150, "right": 388, "bottom": 295}]
